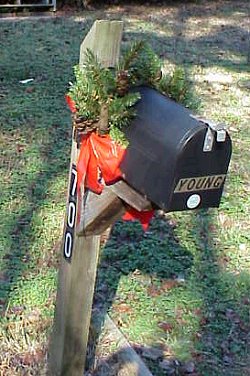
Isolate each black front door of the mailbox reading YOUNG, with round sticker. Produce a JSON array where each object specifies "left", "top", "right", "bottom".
[{"left": 168, "top": 127, "right": 231, "bottom": 211}]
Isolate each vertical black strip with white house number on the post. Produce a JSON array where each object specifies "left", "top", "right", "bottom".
[{"left": 63, "top": 165, "right": 77, "bottom": 260}]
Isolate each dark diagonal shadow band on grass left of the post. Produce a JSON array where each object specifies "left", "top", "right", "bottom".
[{"left": 0, "top": 132, "right": 68, "bottom": 305}]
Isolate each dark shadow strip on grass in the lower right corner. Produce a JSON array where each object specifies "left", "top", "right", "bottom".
[{"left": 189, "top": 212, "right": 250, "bottom": 376}]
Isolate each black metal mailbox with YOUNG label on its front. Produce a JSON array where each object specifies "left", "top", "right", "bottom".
[{"left": 121, "top": 87, "right": 231, "bottom": 211}]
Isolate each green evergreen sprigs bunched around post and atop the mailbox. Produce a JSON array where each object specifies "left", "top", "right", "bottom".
[{"left": 68, "top": 41, "right": 196, "bottom": 142}]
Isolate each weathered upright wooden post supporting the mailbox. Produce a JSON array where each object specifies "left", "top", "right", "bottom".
[{"left": 48, "top": 21, "right": 122, "bottom": 376}]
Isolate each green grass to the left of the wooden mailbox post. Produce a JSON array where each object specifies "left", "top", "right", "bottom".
[{"left": 0, "top": 19, "right": 83, "bottom": 374}]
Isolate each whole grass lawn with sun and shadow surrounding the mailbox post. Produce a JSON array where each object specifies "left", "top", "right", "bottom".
[{"left": 0, "top": 1, "right": 250, "bottom": 376}]
